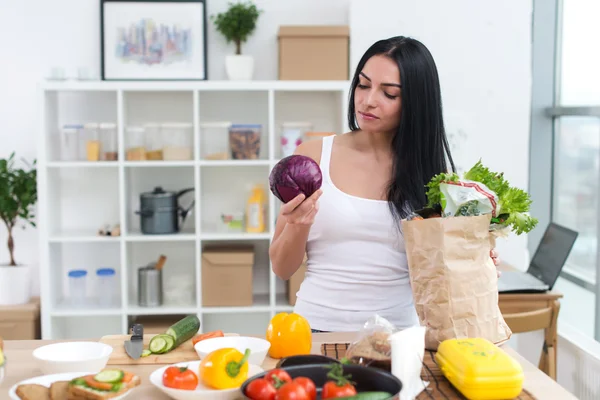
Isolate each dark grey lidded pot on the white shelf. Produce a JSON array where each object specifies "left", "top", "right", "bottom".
[{"left": 135, "top": 186, "right": 195, "bottom": 235}]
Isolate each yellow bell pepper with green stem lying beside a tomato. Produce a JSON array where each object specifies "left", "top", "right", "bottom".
[{"left": 198, "top": 348, "right": 250, "bottom": 390}]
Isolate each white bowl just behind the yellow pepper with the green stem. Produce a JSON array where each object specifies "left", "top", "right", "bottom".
[{"left": 194, "top": 336, "right": 271, "bottom": 365}]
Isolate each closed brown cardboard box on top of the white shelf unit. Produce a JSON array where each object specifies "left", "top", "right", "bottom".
[{"left": 278, "top": 25, "right": 350, "bottom": 80}]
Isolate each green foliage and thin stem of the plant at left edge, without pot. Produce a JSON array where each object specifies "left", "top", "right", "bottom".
[{"left": 0, "top": 152, "right": 37, "bottom": 266}]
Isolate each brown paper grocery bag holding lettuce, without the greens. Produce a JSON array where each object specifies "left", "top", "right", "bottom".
[{"left": 402, "top": 214, "right": 512, "bottom": 351}]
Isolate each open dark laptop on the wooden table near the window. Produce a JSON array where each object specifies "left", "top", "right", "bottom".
[{"left": 498, "top": 222, "right": 579, "bottom": 293}]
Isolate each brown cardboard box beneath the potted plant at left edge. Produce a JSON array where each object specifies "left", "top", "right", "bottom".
[{"left": 0, "top": 297, "right": 42, "bottom": 340}]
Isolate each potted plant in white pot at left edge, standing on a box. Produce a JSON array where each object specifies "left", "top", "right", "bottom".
[{"left": 0, "top": 153, "right": 37, "bottom": 305}]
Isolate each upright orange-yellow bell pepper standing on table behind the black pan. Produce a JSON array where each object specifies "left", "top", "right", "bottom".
[{"left": 266, "top": 313, "right": 312, "bottom": 358}]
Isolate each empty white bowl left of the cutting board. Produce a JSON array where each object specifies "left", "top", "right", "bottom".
[{"left": 33, "top": 342, "right": 113, "bottom": 375}]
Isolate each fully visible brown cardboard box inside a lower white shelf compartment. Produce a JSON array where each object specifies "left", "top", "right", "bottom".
[{"left": 202, "top": 246, "right": 254, "bottom": 307}]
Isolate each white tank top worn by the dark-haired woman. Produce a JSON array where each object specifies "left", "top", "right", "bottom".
[{"left": 294, "top": 136, "right": 419, "bottom": 332}]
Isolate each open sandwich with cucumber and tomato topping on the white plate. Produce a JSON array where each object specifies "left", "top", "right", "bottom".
[{"left": 65, "top": 369, "right": 141, "bottom": 400}]
